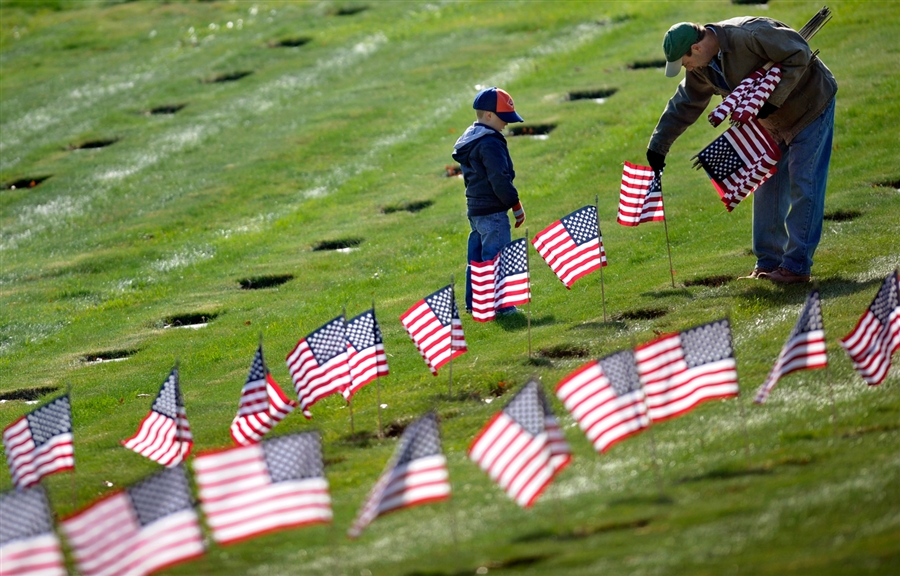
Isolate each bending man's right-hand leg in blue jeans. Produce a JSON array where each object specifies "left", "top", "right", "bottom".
[{"left": 781, "top": 100, "right": 834, "bottom": 276}]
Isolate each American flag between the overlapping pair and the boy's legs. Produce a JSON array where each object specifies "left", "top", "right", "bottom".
[{"left": 400, "top": 284, "right": 468, "bottom": 376}]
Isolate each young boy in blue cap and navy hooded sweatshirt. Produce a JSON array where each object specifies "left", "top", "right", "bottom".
[{"left": 453, "top": 87, "right": 525, "bottom": 315}]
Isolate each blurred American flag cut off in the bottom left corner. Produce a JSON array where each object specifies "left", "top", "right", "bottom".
[{"left": 0, "top": 486, "right": 67, "bottom": 576}]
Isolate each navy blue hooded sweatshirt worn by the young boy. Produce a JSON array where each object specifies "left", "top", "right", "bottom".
[{"left": 453, "top": 122, "right": 519, "bottom": 216}]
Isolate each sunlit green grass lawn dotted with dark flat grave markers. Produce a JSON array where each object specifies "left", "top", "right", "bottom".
[{"left": 0, "top": 0, "right": 900, "bottom": 575}]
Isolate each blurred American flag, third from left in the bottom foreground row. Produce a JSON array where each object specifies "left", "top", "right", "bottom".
[{"left": 193, "top": 432, "right": 331, "bottom": 544}]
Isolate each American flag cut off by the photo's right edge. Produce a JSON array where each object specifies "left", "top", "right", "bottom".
[{"left": 841, "top": 270, "right": 900, "bottom": 386}]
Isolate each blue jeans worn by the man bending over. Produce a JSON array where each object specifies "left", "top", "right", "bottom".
[{"left": 753, "top": 99, "right": 834, "bottom": 275}]
